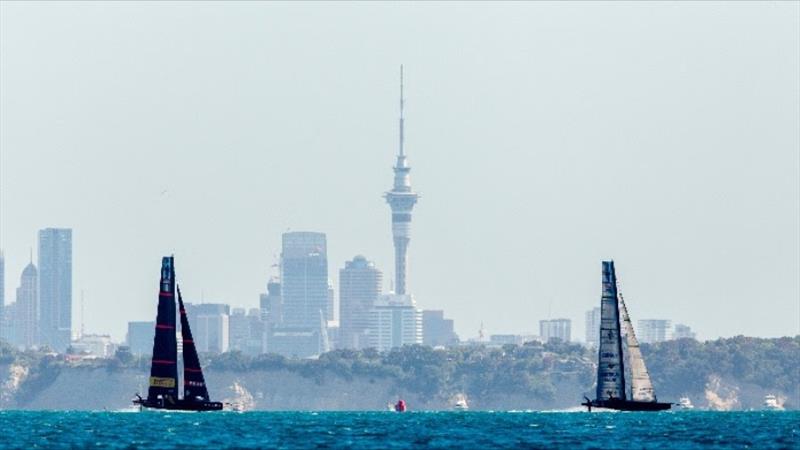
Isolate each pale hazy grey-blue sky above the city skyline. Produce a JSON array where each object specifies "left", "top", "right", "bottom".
[{"left": 0, "top": 2, "right": 800, "bottom": 339}]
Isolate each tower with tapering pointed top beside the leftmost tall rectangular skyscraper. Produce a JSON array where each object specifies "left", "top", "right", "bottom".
[{"left": 11, "top": 262, "right": 38, "bottom": 350}]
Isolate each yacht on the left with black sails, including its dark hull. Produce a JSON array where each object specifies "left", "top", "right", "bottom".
[{"left": 133, "top": 256, "right": 222, "bottom": 411}]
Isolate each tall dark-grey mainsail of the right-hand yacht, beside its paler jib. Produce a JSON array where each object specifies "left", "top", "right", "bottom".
[{"left": 597, "top": 261, "right": 626, "bottom": 400}]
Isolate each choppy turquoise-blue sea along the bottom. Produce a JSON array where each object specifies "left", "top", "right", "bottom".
[{"left": 0, "top": 411, "right": 800, "bottom": 449}]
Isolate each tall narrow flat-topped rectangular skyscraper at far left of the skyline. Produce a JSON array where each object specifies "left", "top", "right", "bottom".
[{"left": 39, "top": 228, "right": 72, "bottom": 353}]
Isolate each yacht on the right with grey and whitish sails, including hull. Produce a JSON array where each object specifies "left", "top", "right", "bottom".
[{"left": 581, "top": 261, "right": 671, "bottom": 411}]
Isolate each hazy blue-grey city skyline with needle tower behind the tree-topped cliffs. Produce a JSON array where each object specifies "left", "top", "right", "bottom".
[{"left": 0, "top": 71, "right": 695, "bottom": 358}]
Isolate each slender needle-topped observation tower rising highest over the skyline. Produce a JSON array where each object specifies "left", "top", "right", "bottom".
[{"left": 384, "top": 65, "right": 419, "bottom": 295}]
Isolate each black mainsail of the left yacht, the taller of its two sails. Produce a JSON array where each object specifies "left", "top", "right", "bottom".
[{"left": 147, "top": 256, "right": 178, "bottom": 403}]
